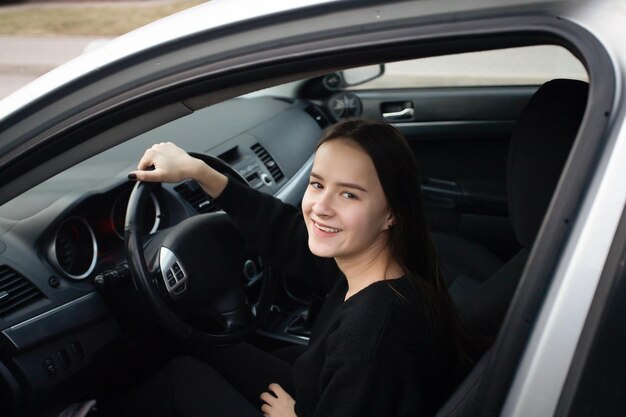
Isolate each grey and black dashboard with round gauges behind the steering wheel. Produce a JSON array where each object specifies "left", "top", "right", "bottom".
[{"left": 0, "top": 97, "right": 327, "bottom": 406}]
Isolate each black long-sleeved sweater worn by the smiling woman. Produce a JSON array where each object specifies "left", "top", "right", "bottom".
[{"left": 215, "top": 178, "right": 450, "bottom": 417}]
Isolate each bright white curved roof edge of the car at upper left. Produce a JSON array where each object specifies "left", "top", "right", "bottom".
[{"left": 0, "top": 0, "right": 338, "bottom": 120}]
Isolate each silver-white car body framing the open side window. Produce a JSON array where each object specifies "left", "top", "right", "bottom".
[{"left": 0, "top": 0, "right": 626, "bottom": 417}]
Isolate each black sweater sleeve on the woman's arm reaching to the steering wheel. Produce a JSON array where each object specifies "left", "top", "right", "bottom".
[{"left": 214, "top": 177, "right": 337, "bottom": 292}]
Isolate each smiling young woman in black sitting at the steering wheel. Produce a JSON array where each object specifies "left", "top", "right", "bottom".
[{"left": 113, "top": 119, "right": 464, "bottom": 417}]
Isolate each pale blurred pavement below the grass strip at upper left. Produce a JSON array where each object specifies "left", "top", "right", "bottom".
[{"left": 0, "top": 36, "right": 106, "bottom": 99}]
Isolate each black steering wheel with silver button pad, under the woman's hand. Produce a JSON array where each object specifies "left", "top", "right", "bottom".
[{"left": 124, "top": 153, "right": 256, "bottom": 345}]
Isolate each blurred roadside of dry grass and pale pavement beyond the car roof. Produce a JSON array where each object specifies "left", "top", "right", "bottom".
[{"left": 0, "top": 0, "right": 206, "bottom": 100}]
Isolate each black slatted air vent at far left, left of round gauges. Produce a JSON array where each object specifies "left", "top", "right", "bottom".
[{"left": 0, "top": 265, "right": 44, "bottom": 317}]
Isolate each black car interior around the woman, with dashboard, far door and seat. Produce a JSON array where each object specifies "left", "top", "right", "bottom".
[{"left": 0, "top": 37, "right": 588, "bottom": 417}]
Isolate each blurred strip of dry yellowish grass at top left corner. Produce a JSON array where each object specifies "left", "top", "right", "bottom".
[{"left": 0, "top": 0, "right": 206, "bottom": 36}]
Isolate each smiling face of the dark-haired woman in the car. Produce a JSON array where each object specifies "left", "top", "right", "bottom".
[{"left": 302, "top": 139, "right": 392, "bottom": 260}]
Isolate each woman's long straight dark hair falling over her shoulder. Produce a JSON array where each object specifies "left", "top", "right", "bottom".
[{"left": 317, "top": 119, "right": 467, "bottom": 376}]
